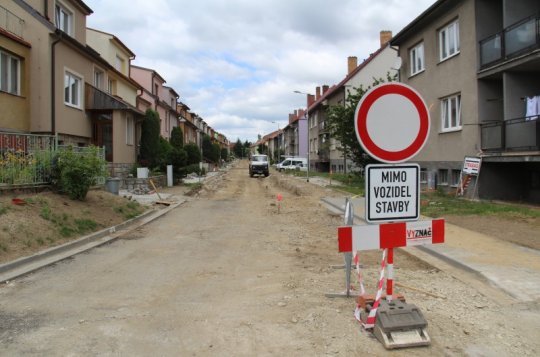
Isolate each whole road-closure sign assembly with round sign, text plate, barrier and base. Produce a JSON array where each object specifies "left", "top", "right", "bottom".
[{"left": 338, "top": 83, "right": 444, "bottom": 348}]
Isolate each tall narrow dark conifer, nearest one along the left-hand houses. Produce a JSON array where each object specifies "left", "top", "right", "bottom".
[{"left": 139, "top": 109, "right": 160, "bottom": 168}]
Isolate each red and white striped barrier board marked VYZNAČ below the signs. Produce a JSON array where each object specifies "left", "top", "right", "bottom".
[{"left": 338, "top": 219, "right": 444, "bottom": 253}]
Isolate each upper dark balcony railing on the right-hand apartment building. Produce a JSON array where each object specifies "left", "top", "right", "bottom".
[{"left": 480, "top": 15, "right": 540, "bottom": 68}]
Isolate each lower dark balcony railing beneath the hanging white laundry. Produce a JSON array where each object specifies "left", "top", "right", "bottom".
[{"left": 481, "top": 117, "right": 540, "bottom": 152}]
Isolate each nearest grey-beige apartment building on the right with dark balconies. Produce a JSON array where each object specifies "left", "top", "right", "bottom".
[{"left": 391, "top": 0, "right": 540, "bottom": 202}]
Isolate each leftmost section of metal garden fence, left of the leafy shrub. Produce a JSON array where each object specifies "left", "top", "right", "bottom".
[{"left": 0, "top": 132, "right": 56, "bottom": 187}]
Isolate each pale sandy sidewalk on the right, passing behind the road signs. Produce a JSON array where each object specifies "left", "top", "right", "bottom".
[{"left": 322, "top": 197, "right": 540, "bottom": 302}]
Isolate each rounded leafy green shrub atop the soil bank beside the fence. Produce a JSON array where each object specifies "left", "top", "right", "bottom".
[{"left": 54, "top": 146, "right": 107, "bottom": 201}]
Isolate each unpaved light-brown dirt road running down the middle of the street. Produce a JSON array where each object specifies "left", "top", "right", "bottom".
[{"left": 0, "top": 162, "right": 540, "bottom": 356}]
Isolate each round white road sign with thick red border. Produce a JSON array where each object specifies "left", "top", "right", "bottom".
[{"left": 354, "top": 83, "right": 430, "bottom": 164}]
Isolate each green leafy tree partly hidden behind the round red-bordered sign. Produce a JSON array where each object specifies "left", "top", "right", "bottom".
[{"left": 326, "top": 73, "right": 396, "bottom": 167}]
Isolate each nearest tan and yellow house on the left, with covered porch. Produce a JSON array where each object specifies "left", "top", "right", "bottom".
[{"left": 0, "top": 0, "right": 140, "bottom": 163}]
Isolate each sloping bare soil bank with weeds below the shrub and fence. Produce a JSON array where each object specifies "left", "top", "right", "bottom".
[{"left": 0, "top": 190, "right": 149, "bottom": 263}]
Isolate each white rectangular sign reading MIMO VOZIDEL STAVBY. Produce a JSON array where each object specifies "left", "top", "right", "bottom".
[{"left": 366, "top": 164, "right": 420, "bottom": 222}]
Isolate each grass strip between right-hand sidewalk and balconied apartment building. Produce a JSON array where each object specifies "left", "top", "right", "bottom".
[{"left": 421, "top": 192, "right": 540, "bottom": 218}]
